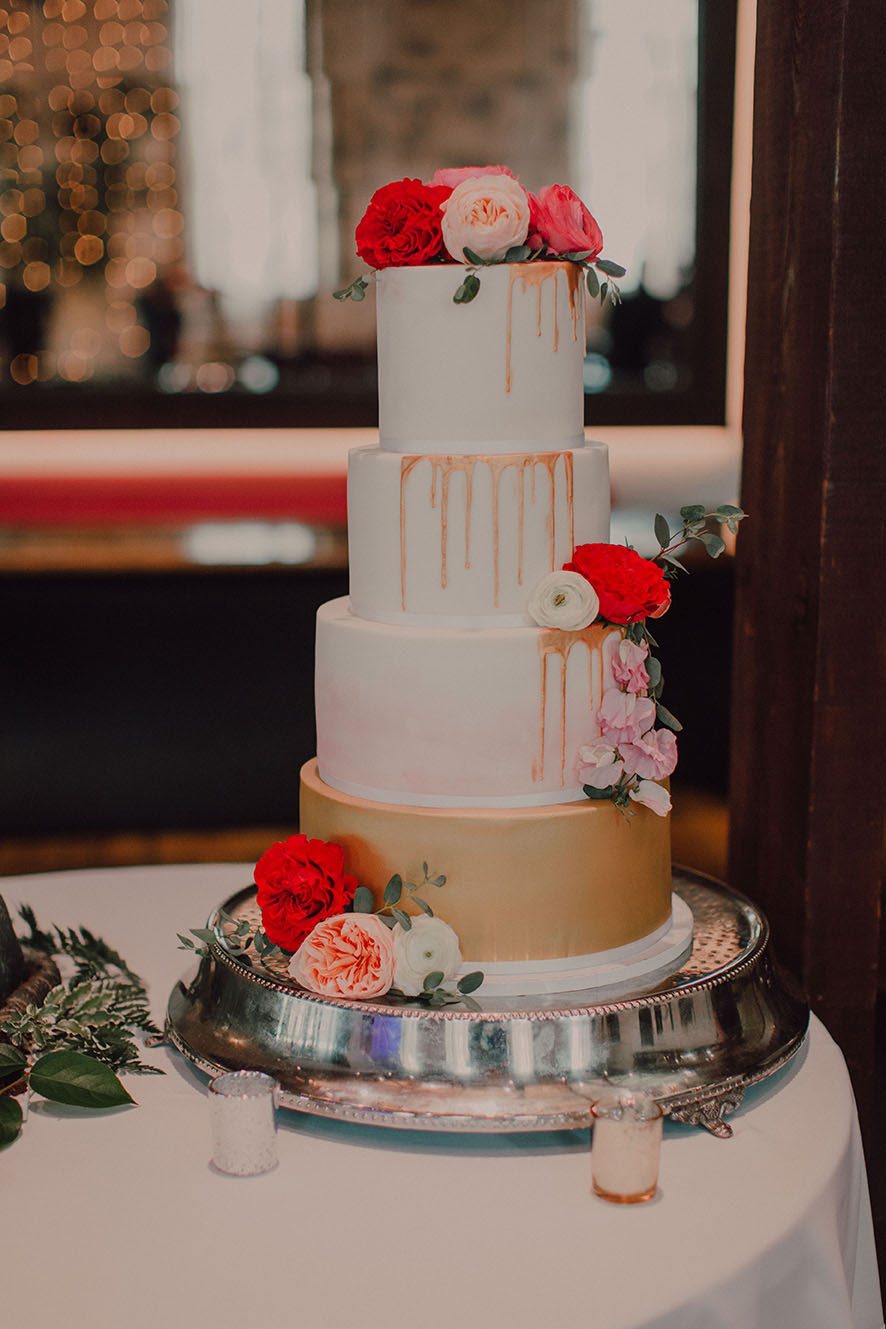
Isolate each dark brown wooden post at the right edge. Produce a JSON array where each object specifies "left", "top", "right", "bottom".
[{"left": 731, "top": 0, "right": 886, "bottom": 1115}]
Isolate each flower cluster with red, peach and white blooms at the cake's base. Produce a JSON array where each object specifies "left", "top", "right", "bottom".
[{"left": 179, "top": 835, "right": 484, "bottom": 1007}]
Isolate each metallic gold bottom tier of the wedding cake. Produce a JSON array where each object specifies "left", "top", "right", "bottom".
[{"left": 300, "top": 760, "right": 671, "bottom": 962}]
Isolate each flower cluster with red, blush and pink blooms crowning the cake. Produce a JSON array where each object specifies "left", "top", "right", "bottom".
[{"left": 335, "top": 166, "right": 624, "bottom": 304}]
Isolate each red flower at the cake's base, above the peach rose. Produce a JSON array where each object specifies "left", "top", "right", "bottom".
[{"left": 255, "top": 835, "right": 357, "bottom": 950}]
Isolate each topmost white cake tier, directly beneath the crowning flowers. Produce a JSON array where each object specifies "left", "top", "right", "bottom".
[{"left": 377, "top": 262, "right": 584, "bottom": 455}]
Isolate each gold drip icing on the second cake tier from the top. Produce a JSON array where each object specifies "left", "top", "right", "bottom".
[{"left": 400, "top": 449, "right": 575, "bottom": 613}]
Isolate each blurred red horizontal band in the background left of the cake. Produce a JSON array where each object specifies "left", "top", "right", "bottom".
[{"left": 0, "top": 473, "right": 347, "bottom": 526}]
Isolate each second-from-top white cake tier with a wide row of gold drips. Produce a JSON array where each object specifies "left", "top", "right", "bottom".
[{"left": 348, "top": 435, "right": 610, "bottom": 627}]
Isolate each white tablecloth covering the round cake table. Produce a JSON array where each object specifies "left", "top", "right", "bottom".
[{"left": 0, "top": 865, "right": 883, "bottom": 1329}]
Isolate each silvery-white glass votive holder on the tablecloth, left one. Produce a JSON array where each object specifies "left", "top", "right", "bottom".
[{"left": 209, "top": 1071, "right": 278, "bottom": 1176}]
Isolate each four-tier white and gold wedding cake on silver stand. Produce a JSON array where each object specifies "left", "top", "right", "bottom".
[{"left": 290, "top": 179, "right": 691, "bottom": 993}]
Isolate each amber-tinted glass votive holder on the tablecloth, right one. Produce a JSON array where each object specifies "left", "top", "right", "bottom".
[{"left": 591, "top": 1090, "right": 662, "bottom": 1204}]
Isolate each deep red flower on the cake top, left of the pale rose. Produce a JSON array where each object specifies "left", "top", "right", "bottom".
[{"left": 356, "top": 179, "right": 452, "bottom": 267}]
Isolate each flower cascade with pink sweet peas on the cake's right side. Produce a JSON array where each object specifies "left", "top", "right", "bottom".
[{"left": 527, "top": 504, "right": 745, "bottom": 817}]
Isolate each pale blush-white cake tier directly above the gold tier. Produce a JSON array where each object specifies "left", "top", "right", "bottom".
[{"left": 316, "top": 598, "right": 620, "bottom": 808}]
